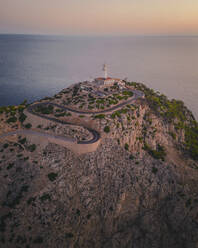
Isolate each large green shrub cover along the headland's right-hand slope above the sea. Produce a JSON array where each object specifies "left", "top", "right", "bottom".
[{"left": 127, "top": 82, "right": 198, "bottom": 160}]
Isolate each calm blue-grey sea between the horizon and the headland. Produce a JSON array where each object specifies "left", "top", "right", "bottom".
[{"left": 0, "top": 35, "right": 198, "bottom": 119}]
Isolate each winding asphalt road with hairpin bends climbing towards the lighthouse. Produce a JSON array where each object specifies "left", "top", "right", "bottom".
[{"left": 0, "top": 90, "right": 144, "bottom": 144}]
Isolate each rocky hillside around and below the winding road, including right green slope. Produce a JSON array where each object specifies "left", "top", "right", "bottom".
[{"left": 0, "top": 80, "right": 198, "bottom": 248}]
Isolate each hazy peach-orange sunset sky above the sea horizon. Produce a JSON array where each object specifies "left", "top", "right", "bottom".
[{"left": 0, "top": 0, "right": 198, "bottom": 35}]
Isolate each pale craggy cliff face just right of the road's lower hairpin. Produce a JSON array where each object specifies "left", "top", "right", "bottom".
[{"left": 94, "top": 100, "right": 185, "bottom": 163}]
